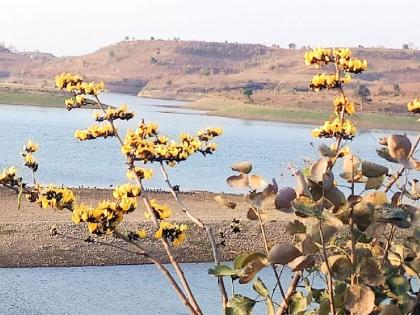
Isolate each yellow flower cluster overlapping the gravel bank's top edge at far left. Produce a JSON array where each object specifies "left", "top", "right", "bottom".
[{"left": 27, "top": 184, "right": 75, "bottom": 210}]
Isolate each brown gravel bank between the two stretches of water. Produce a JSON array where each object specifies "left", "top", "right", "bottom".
[{"left": 0, "top": 189, "right": 292, "bottom": 267}]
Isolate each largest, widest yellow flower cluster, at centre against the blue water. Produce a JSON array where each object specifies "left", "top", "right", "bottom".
[{"left": 122, "top": 122, "right": 221, "bottom": 165}]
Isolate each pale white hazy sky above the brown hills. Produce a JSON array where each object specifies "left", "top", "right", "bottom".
[{"left": 0, "top": 0, "right": 420, "bottom": 55}]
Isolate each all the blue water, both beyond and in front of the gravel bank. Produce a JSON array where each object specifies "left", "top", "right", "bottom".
[{"left": 0, "top": 93, "right": 414, "bottom": 315}]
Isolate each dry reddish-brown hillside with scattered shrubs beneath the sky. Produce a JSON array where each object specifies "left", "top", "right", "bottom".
[{"left": 0, "top": 40, "right": 420, "bottom": 112}]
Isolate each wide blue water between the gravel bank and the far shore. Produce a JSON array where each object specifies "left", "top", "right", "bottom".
[{"left": 0, "top": 93, "right": 414, "bottom": 192}]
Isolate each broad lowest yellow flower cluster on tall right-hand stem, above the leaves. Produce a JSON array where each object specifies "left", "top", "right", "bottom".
[{"left": 312, "top": 117, "right": 356, "bottom": 140}]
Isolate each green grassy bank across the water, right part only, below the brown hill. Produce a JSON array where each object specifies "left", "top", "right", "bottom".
[{"left": 186, "top": 98, "right": 420, "bottom": 130}]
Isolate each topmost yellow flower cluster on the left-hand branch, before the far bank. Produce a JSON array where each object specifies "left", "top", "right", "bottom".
[{"left": 55, "top": 73, "right": 105, "bottom": 95}]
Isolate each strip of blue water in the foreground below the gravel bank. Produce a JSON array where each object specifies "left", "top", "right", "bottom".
[{"left": 0, "top": 263, "right": 291, "bottom": 315}]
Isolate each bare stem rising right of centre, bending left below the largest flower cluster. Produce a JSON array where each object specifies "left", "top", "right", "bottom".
[{"left": 160, "top": 162, "right": 228, "bottom": 309}]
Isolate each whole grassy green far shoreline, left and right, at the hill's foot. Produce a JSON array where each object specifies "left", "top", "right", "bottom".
[{"left": 0, "top": 88, "right": 420, "bottom": 131}]
